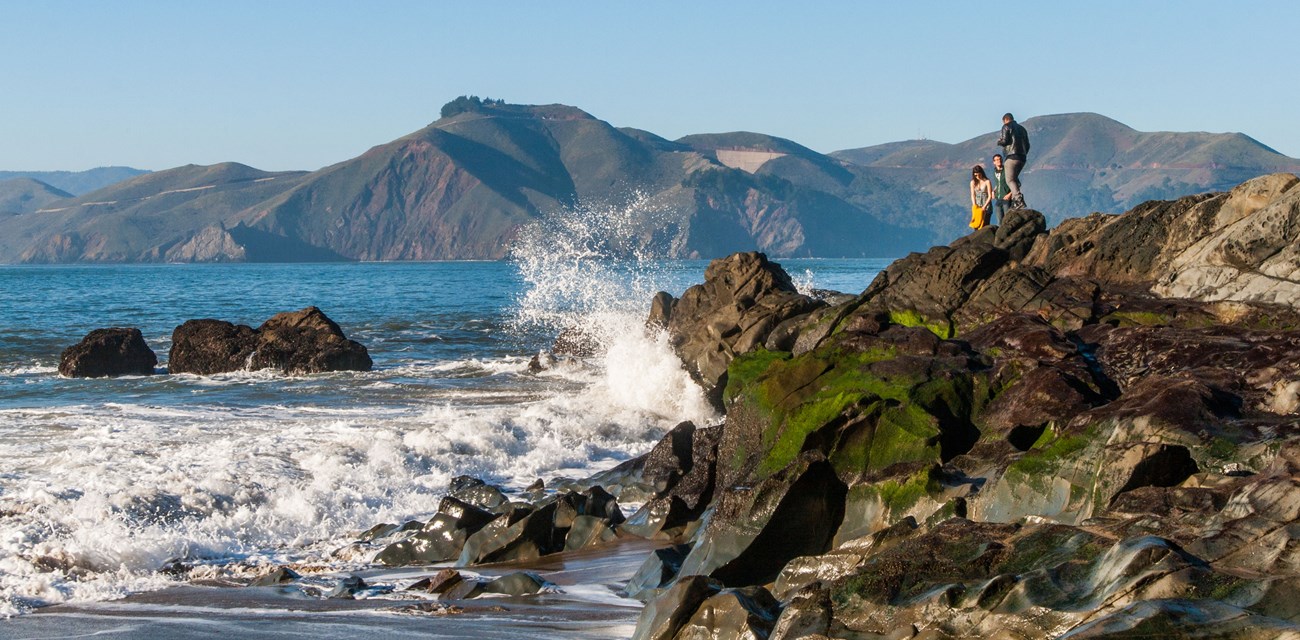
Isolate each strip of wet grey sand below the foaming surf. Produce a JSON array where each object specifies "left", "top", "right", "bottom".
[{"left": 0, "top": 540, "right": 662, "bottom": 640}]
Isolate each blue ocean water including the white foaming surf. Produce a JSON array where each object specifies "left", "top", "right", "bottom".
[{"left": 0, "top": 243, "right": 888, "bottom": 618}]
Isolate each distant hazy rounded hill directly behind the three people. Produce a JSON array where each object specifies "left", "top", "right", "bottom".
[{"left": 831, "top": 113, "right": 1300, "bottom": 237}]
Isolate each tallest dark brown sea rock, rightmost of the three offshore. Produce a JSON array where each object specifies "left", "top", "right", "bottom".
[{"left": 248, "top": 307, "right": 373, "bottom": 373}]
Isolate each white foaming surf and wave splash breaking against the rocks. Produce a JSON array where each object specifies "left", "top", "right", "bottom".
[{"left": 0, "top": 195, "right": 715, "bottom": 617}]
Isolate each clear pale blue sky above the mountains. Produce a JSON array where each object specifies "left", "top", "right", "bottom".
[{"left": 0, "top": 0, "right": 1300, "bottom": 170}]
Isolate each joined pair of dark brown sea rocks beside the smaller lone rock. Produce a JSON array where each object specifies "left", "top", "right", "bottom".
[{"left": 168, "top": 307, "right": 373, "bottom": 375}]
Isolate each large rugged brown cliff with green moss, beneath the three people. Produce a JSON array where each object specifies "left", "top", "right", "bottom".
[{"left": 629, "top": 174, "right": 1300, "bottom": 639}]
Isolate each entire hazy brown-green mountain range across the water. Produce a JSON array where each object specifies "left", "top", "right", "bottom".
[{"left": 0, "top": 99, "right": 1300, "bottom": 263}]
